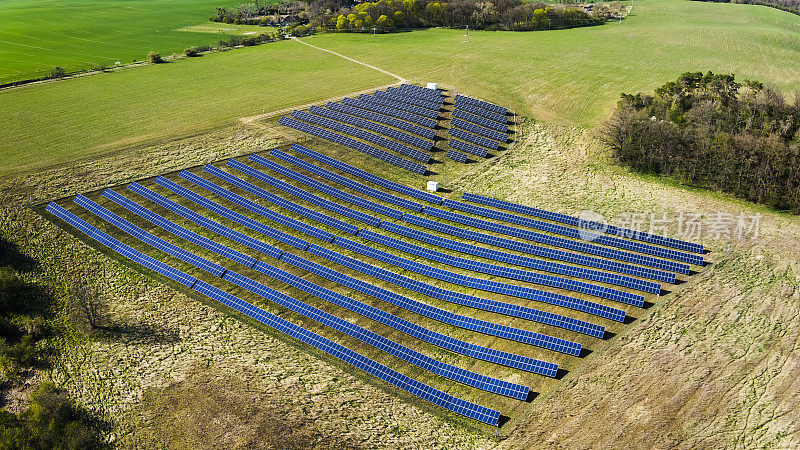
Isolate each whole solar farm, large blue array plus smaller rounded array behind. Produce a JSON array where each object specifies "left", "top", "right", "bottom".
[{"left": 40, "top": 84, "right": 705, "bottom": 428}]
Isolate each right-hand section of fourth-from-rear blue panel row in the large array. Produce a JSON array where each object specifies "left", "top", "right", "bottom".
[{"left": 403, "top": 214, "right": 675, "bottom": 283}]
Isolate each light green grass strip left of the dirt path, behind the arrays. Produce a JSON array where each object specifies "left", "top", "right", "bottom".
[{"left": 0, "top": 41, "right": 394, "bottom": 176}]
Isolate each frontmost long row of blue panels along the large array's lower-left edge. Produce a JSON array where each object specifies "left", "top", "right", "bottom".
[{"left": 47, "top": 203, "right": 504, "bottom": 426}]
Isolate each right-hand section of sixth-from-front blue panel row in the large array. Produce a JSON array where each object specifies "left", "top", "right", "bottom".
[{"left": 333, "top": 230, "right": 625, "bottom": 324}]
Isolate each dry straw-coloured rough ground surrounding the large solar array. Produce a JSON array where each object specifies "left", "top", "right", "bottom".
[{"left": 0, "top": 118, "right": 800, "bottom": 448}]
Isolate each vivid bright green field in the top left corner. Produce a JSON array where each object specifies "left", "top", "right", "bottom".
[{"left": 0, "top": 0, "right": 272, "bottom": 83}]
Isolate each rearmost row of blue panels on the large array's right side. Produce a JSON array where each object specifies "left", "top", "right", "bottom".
[{"left": 462, "top": 193, "right": 704, "bottom": 254}]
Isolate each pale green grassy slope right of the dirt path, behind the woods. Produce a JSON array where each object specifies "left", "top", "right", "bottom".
[{"left": 306, "top": 0, "right": 800, "bottom": 125}]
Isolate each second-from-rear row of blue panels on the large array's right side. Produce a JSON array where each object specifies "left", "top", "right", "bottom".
[{"left": 442, "top": 199, "right": 703, "bottom": 265}]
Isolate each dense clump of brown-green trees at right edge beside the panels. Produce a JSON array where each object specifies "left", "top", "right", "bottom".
[{"left": 604, "top": 72, "right": 800, "bottom": 213}]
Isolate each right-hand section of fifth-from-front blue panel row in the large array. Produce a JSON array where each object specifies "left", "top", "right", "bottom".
[{"left": 308, "top": 245, "right": 605, "bottom": 338}]
